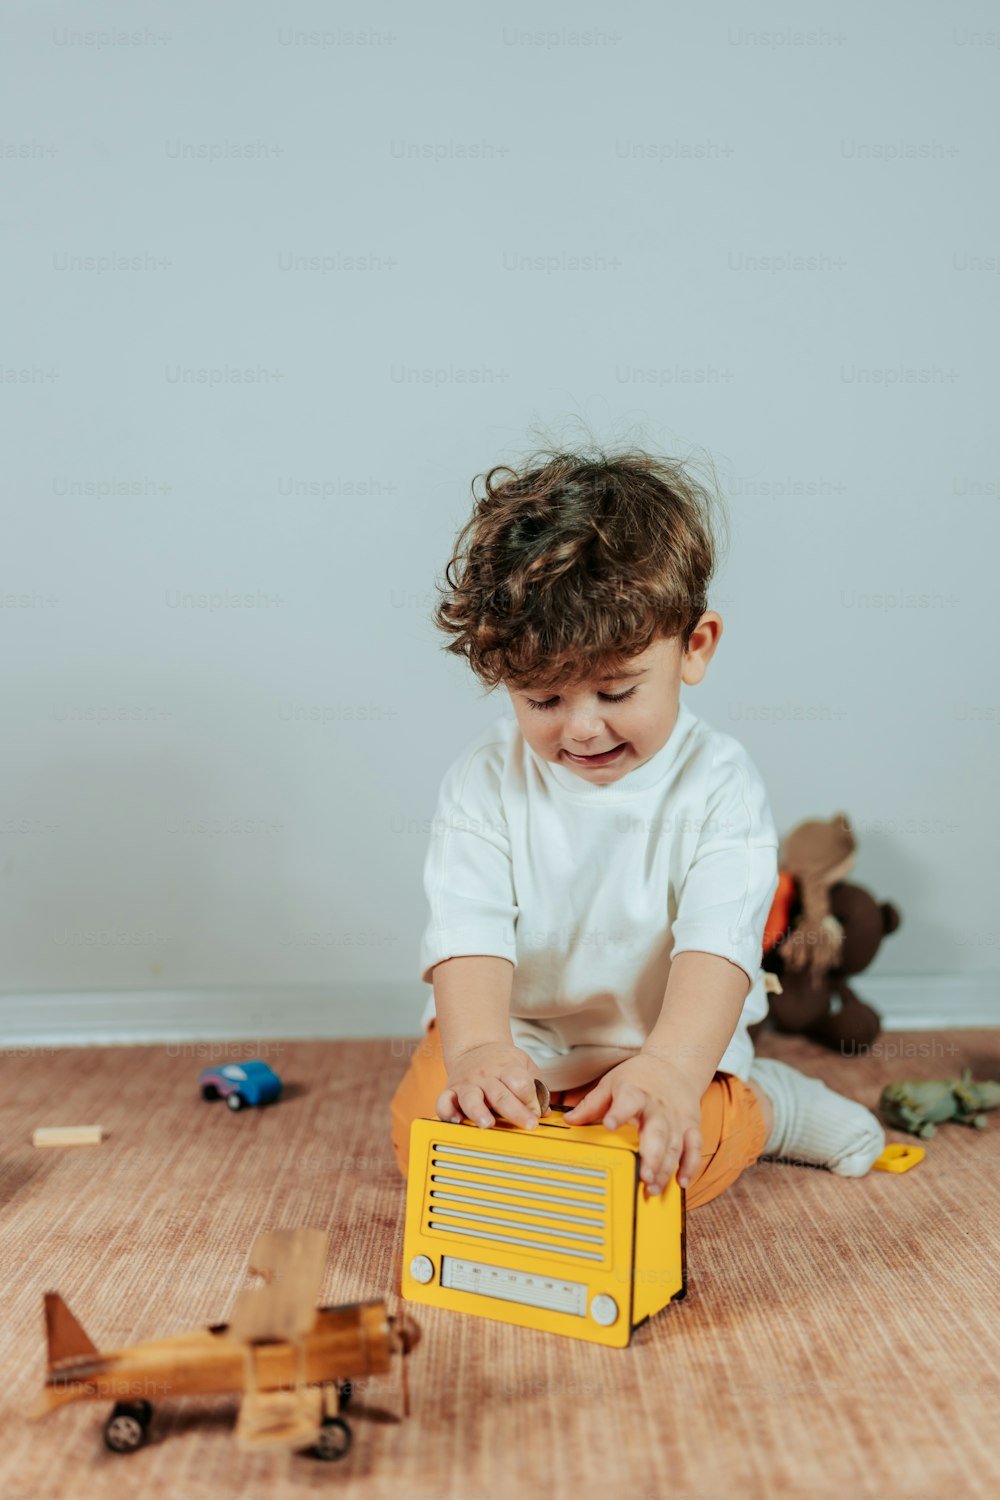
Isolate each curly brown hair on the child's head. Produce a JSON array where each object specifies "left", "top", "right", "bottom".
[{"left": 433, "top": 449, "right": 728, "bottom": 690}]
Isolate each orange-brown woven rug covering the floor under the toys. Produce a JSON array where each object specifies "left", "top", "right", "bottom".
[{"left": 0, "top": 1031, "right": 1000, "bottom": 1500}]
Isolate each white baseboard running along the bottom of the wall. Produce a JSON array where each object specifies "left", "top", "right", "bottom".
[{"left": 0, "top": 974, "right": 1000, "bottom": 1050}]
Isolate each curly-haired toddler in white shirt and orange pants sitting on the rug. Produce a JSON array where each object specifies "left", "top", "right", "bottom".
[{"left": 393, "top": 452, "right": 885, "bottom": 1208}]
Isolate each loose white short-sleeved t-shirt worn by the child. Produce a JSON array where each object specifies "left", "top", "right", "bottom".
[{"left": 420, "top": 701, "right": 778, "bottom": 1089}]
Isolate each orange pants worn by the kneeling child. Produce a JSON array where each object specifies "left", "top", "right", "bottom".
[{"left": 391, "top": 1020, "right": 768, "bottom": 1209}]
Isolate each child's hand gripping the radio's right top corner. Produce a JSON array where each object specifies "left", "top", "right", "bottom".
[{"left": 562, "top": 1052, "right": 702, "bottom": 1194}]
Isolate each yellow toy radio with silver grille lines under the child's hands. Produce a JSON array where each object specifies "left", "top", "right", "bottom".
[{"left": 402, "top": 1110, "right": 687, "bottom": 1349}]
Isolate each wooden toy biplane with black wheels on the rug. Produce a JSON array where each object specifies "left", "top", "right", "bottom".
[{"left": 28, "top": 1229, "right": 420, "bottom": 1460}]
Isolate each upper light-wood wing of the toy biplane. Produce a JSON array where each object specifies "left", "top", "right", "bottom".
[{"left": 226, "top": 1229, "right": 328, "bottom": 1343}]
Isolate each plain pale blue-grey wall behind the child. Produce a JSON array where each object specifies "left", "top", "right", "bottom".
[{"left": 0, "top": 0, "right": 1000, "bottom": 1031}]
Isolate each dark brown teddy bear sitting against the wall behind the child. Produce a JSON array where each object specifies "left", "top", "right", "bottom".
[{"left": 750, "top": 881, "right": 901, "bottom": 1055}]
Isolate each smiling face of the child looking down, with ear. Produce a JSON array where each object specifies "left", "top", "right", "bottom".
[{"left": 508, "top": 612, "right": 723, "bottom": 786}]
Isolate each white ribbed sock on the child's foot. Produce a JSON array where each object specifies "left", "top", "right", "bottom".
[{"left": 750, "top": 1058, "right": 886, "bottom": 1178}]
